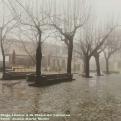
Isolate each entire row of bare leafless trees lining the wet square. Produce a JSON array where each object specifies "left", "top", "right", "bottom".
[{"left": 0, "top": 0, "right": 121, "bottom": 77}]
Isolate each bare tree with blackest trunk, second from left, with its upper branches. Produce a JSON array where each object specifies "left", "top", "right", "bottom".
[{"left": 9, "top": 0, "right": 46, "bottom": 79}]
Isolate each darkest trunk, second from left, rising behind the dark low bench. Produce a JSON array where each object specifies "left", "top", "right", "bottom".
[{"left": 36, "top": 33, "right": 42, "bottom": 76}]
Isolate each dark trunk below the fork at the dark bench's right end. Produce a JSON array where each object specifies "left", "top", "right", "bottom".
[{"left": 67, "top": 41, "right": 73, "bottom": 75}]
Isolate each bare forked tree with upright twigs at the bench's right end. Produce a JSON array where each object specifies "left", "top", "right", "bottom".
[{"left": 49, "top": 0, "right": 89, "bottom": 74}]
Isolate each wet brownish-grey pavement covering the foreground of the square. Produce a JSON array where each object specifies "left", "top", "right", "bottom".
[{"left": 0, "top": 74, "right": 121, "bottom": 121}]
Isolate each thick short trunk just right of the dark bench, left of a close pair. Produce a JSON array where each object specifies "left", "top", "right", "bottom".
[{"left": 84, "top": 56, "right": 90, "bottom": 78}]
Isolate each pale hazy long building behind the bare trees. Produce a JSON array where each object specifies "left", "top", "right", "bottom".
[{"left": 0, "top": 40, "right": 82, "bottom": 72}]
